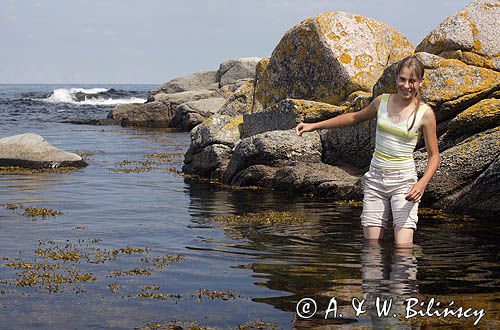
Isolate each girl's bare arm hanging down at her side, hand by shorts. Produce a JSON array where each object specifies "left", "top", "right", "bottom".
[{"left": 406, "top": 108, "right": 439, "bottom": 202}]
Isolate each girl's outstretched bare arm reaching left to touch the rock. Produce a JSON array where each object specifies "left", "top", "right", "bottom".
[{"left": 295, "top": 96, "right": 381, "bottom": 136}]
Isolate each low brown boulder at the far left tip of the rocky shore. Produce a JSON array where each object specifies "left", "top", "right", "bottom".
[{"left": 108, "top": 102, "right": 175, "bottom": 127}]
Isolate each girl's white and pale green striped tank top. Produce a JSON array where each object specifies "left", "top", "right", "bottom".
[{"left": 371, "top": 94, "right": 428, "bottom": 170}]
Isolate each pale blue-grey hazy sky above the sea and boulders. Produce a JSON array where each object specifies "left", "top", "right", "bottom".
[{"left": 0, "top": 0, "right": 471, "bottom": 84}]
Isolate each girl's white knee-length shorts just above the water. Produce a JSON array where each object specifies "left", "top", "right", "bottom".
[{"left": 361, "top": 166, "right": 418, "bottom": 229}]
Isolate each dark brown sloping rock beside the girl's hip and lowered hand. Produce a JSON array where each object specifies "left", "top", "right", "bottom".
[{"left": 415, "top": 127, "right": 500, "bottom": 208}]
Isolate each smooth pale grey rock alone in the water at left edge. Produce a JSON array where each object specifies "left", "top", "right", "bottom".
[{"left": 0, "top": 133, "right": 87, "bottom": 168}]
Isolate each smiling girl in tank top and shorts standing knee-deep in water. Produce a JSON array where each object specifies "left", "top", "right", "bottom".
[{"left": 295, "top": 56, "right": 439, "bottom": 247}]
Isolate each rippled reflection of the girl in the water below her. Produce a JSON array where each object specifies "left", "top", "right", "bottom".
[{"left": 361, "top": 241, "right": 419, "bottom": 329}]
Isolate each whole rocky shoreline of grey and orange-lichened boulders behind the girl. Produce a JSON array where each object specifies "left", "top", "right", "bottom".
[{"left": 110, "top": 0, "right": 500, "bottom": 217}]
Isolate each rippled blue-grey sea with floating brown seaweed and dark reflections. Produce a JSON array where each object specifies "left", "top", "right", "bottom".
[{"left": 0, "top": 84, "right": 500, "bottom": 329}]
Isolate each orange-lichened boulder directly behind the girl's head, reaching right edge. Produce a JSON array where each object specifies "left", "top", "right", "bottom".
[{"left": 373, "top": 53, "right": 500, "bottom": 122}]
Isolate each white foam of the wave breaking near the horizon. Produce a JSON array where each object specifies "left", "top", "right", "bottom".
[{"left": 36, "top": 88, "right": 146, "bottom": 105}]
